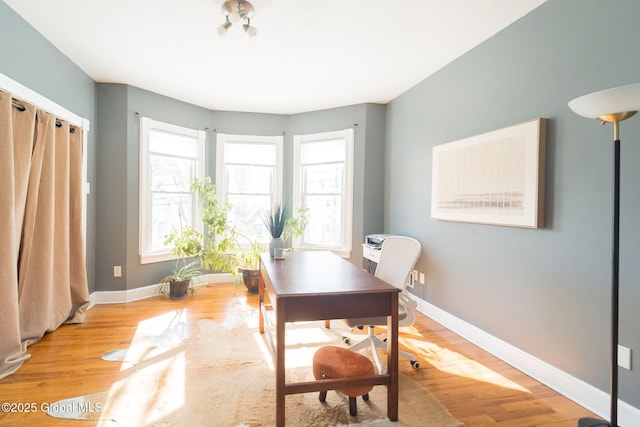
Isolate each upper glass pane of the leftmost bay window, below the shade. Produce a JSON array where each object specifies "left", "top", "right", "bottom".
[{"left": 150, "top": 155, "right": 195, "bottom": 192}]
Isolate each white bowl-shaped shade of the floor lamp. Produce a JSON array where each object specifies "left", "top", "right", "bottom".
[{"left": 569, "top": 83, "right": 640, "bottom": 119}]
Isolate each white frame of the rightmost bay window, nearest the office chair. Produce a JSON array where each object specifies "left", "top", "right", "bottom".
[{"left": 293, "top": 128, "right": 355, "bottom": 258}]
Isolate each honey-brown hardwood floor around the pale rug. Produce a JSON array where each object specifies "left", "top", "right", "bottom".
[{"left": 0, "top": 284, "right": 594, "bottom": 427}]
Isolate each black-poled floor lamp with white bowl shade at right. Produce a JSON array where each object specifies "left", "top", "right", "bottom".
[{"left": 569, "top": 83, "right": 640, "bottom": 427}]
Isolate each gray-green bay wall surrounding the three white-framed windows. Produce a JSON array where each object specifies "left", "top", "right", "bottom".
[{"left": 95, "top": 87, "right": 385, "bottom": 291}]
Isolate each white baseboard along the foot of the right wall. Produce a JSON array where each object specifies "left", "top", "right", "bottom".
[{"left": 412, "top": 295, "right": 640, "bottom": 427}]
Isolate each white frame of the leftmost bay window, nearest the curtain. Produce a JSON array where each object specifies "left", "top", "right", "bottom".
[{"left": 138, "top": 117, "right": 207, "bottom": 264}]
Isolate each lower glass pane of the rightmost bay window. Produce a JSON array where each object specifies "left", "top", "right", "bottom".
[{"left": 304, "top": 195, "right": 342, "bottom": 246}]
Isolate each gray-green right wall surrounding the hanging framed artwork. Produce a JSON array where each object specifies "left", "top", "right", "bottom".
[{"left": 385, "top": 0, "right": 640, "bottom": 408}]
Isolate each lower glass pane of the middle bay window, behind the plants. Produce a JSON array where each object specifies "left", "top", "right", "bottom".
[{"left": 229, "top": 195, "right": 271, "bottom": 244}]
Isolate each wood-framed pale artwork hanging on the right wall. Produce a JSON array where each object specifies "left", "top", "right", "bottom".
[{"left": 431, "top": 118, "right": 547, "bottom": 228}]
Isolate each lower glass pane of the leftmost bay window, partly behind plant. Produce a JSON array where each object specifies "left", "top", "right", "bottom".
[{"left": 151, "top": 193, "right": 193, "bottom": 252}]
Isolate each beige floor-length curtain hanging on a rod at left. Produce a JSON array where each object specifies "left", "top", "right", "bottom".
[{"left": 0, "top": 92, "right": 89, "bottom": 378}]
